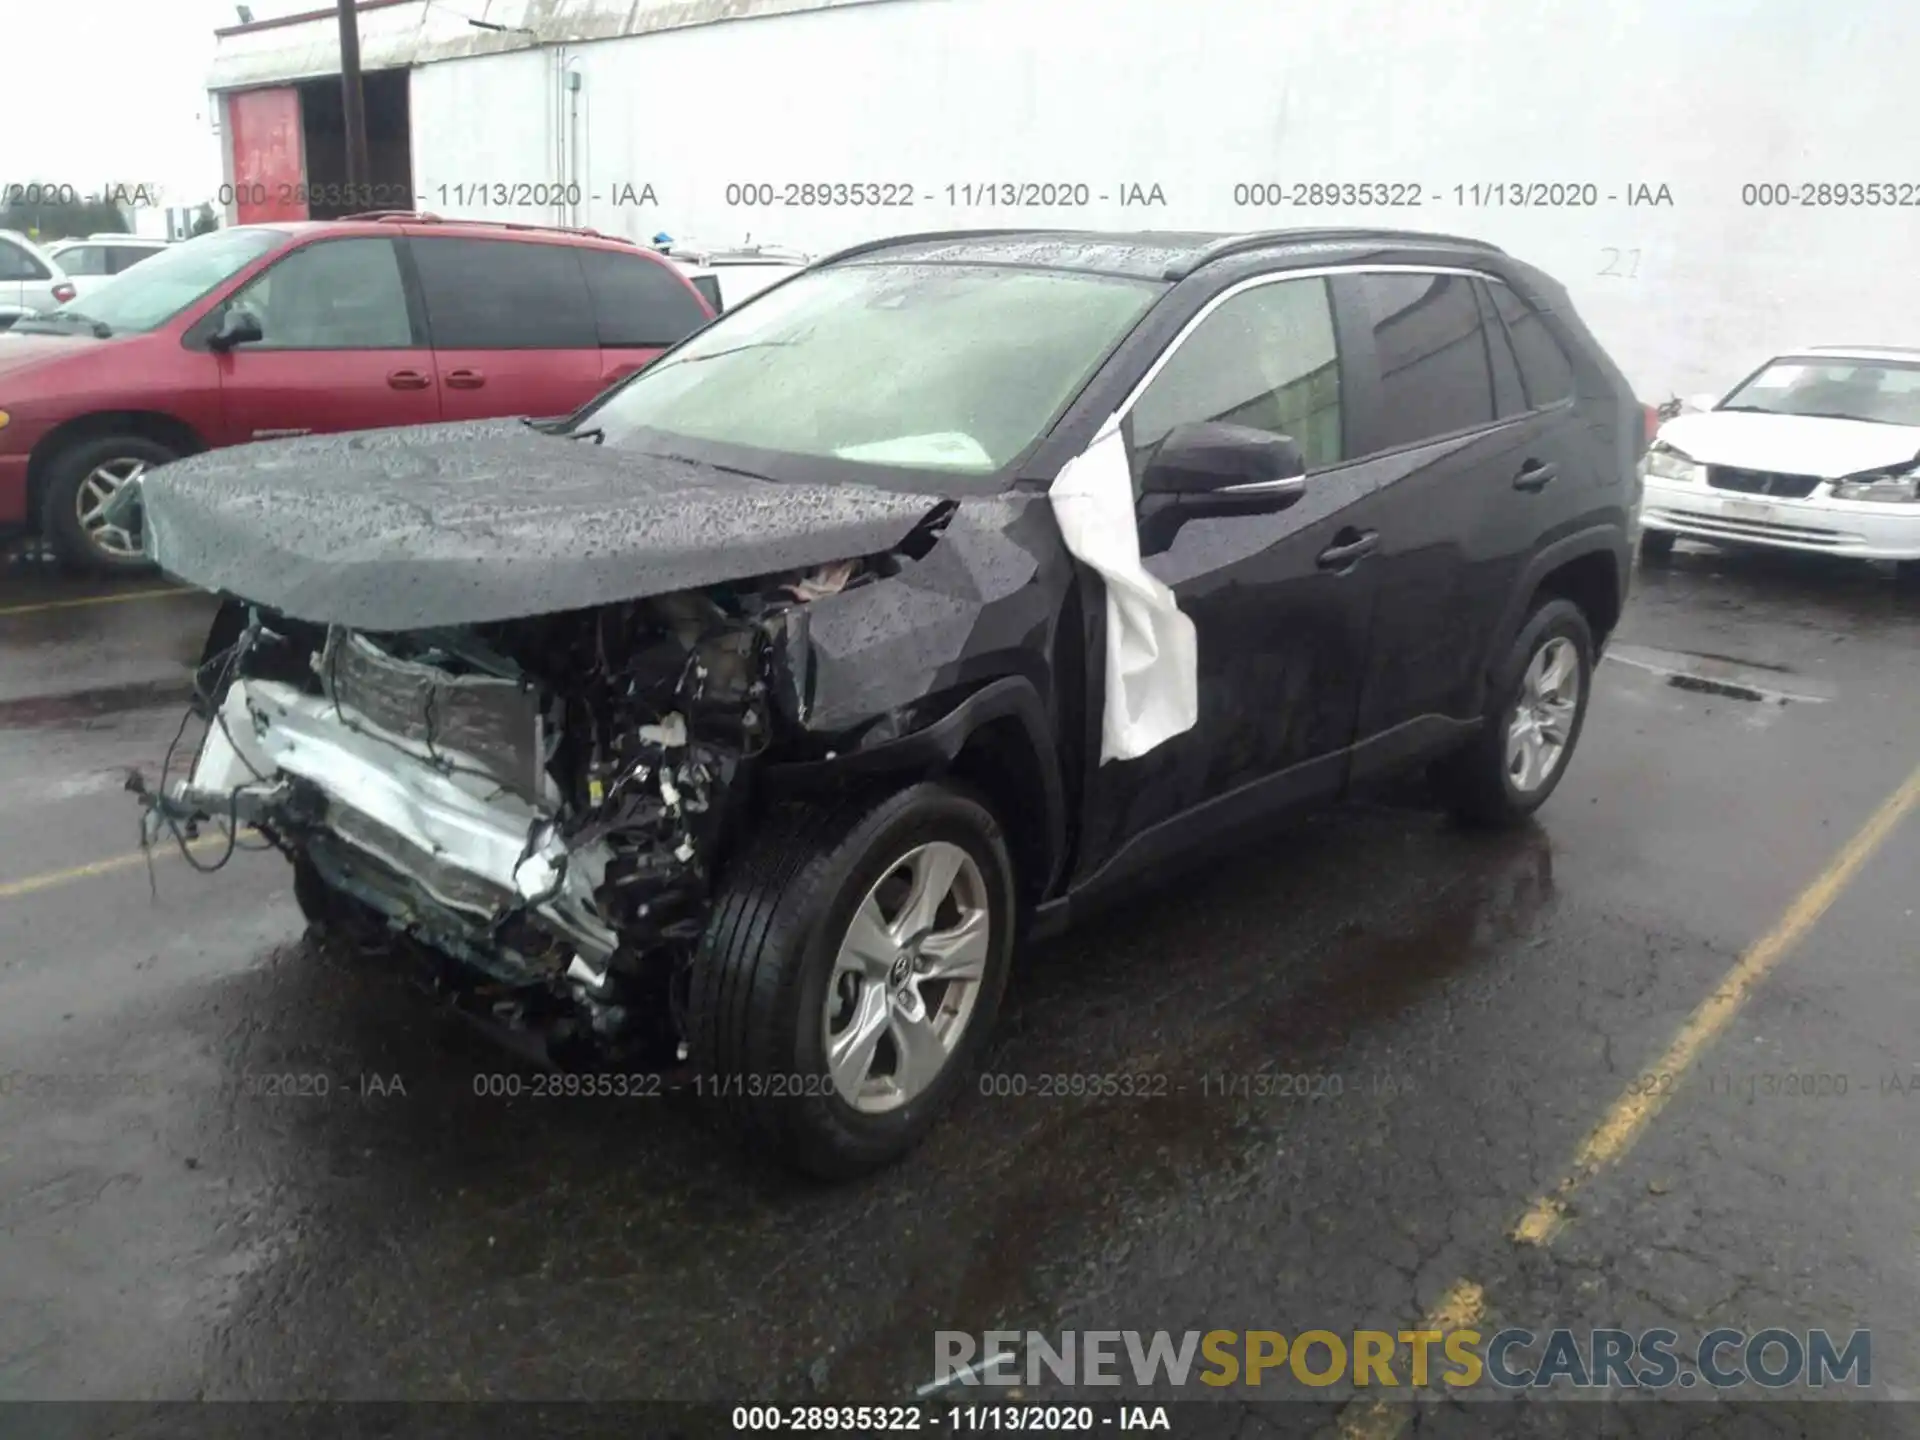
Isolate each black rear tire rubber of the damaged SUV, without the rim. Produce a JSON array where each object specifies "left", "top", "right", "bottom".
[{"left": 1434, "top": 599, "right": 1594, "bottom": 829}]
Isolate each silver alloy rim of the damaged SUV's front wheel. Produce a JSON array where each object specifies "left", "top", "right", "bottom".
[{"left": 822, "top": 841, "right": 993, "bottom": 1116}]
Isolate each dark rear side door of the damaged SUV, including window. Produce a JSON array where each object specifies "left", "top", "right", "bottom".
[{"left": 1336, "top": 267, "right": 1524, "bottom": 780}]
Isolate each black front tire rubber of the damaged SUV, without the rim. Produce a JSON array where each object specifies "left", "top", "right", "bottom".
[{"left": 687, "top": 783, "right": 1014, "bottom": 1179}]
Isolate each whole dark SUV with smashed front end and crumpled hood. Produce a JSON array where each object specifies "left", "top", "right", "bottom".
[{"left": 138, "top": 230, "right": 1645, "bottom": 1177}]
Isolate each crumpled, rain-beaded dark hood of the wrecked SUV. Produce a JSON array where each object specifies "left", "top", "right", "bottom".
[{"left": 140, "top": 420, "right": 956, "bottom": 630}]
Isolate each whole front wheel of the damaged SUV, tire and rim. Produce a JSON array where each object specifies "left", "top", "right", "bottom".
[{"left": 687, "top": 783, "right": 1014, "bottom": 1179}]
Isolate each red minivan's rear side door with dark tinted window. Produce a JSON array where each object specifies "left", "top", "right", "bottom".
[{"left": 407, "top": 230, "right": 601, "bottom": 420}]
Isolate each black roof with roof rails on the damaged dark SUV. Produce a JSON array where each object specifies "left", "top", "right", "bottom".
[{"left": 820, "top": 228, "right": 1505, "bottom": 280}]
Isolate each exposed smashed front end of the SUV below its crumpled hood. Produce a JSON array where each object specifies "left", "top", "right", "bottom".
[{"left": 131, "top": 555, "right": 887, "bottom": 1064}]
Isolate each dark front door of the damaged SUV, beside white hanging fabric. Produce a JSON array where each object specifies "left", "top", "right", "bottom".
[{"left": 1077, "top": 276, "right": 1379, "bottom": 877}]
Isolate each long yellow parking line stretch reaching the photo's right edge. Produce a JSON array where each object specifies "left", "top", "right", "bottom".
[{"left": 1513, "top": 768, "right": 1920, "bottom": 1244}]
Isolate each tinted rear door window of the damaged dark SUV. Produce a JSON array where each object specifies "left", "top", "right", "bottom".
[{"left": 1359, "top": 273, "right": 1494, "bottom": 449}]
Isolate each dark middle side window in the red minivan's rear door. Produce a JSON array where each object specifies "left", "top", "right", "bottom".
[{"left": 409, "top": 236, "right": 599, "bottom": 349}]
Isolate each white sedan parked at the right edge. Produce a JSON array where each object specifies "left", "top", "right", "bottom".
[{"left": 1640, "top": 346, "right": 1920, "bottom": 578}]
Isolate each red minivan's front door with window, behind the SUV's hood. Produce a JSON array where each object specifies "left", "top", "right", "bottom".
[{"left": 204, "top": 236, "right": 440, "bottom": 445}]
